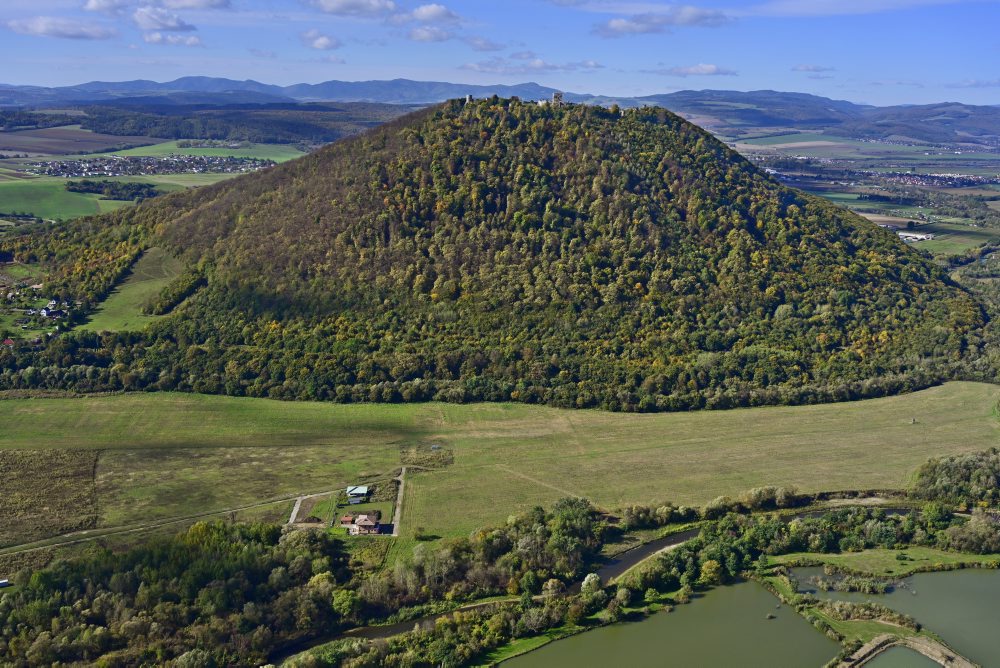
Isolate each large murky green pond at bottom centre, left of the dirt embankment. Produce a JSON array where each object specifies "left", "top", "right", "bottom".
[{"left": 503, "top": 582, "right": 840, "bottom": 668}]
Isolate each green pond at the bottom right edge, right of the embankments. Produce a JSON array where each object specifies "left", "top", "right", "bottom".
[{"left": 794, "top": 569, "right": 1000, "bottom": 668}]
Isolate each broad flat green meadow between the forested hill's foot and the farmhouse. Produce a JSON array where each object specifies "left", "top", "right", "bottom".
[{"left": 0, "top": 383, "right": 1000, "bottom": 551}]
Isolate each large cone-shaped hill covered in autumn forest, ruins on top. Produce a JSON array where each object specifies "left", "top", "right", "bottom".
[{"left": 0, "top": 98, "right": 983, "bottom": 410}]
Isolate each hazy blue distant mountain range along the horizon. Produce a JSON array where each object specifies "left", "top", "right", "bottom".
[{"left": 0, "top": 77, "right": 1000, "bottom": 146}]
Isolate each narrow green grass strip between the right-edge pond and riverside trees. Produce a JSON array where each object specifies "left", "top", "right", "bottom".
[{"left": 770, "top": 546, "right": 1000, "bottom": 577}]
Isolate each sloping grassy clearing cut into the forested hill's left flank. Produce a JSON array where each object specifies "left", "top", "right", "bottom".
[{"left": 80, "top": 248, "right": 183, "bottom": 332}]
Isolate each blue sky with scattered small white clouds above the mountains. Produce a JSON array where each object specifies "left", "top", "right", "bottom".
[{"left": 0, "top": 0, "right": 1000, "bottom": 105}]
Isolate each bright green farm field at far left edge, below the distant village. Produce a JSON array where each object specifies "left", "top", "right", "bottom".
[{"left": 0, "top": 177, "right": 129, "bottom": 220}]
